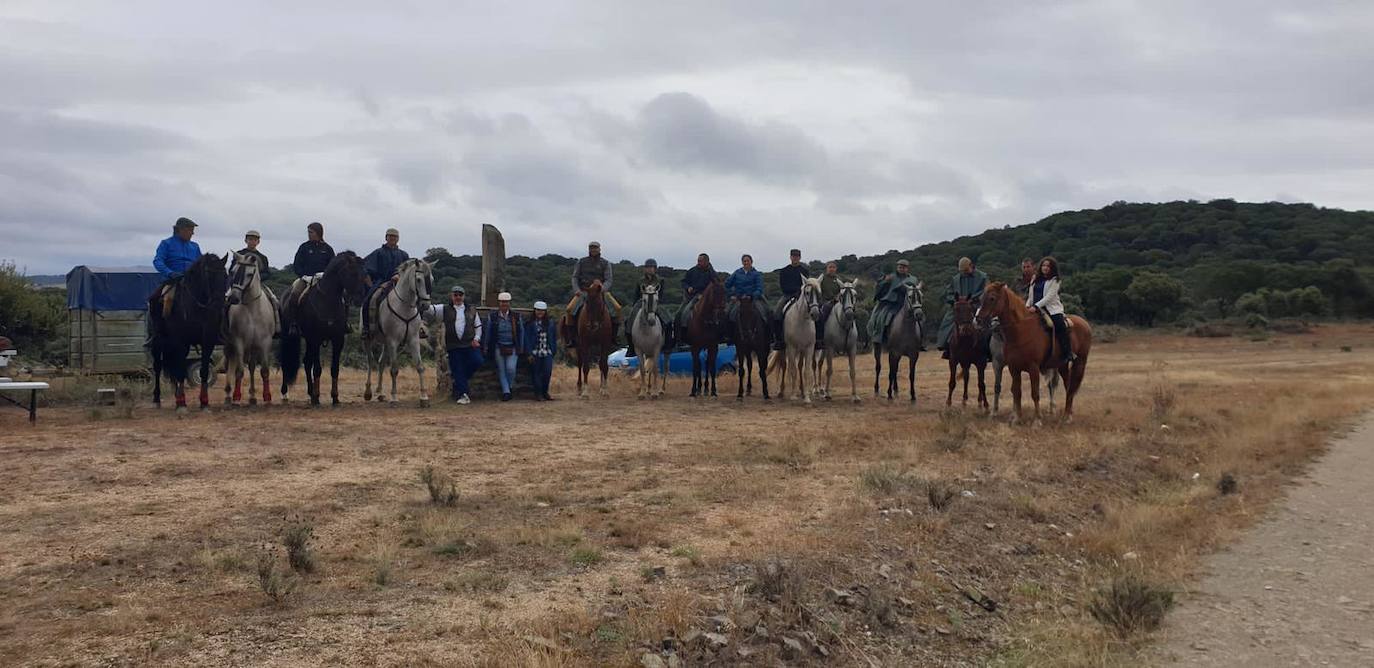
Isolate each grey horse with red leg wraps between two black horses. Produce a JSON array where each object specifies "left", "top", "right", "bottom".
[{"left": 224, "top": 253, "right": 278, "bottom": 405}]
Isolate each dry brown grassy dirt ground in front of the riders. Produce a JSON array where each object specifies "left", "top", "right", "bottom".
[{"left": 0, "top": 326, "right": 1374, "bottom": 665}]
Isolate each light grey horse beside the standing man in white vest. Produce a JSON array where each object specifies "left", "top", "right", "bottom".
[{"left": 363, "top": 257, "right": 434, "bottom": 407}]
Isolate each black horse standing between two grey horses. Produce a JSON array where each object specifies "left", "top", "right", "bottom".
[{"left": 279, "top": 250, "right": 371, "bottom": 407}]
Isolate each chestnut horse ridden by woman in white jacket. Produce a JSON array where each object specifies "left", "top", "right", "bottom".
[{"left": 977, "top": 282, "right": 1092, "bottom": 422}]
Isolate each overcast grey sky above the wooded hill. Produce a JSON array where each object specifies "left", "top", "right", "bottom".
[{"left": 0, "top": 0, "right": 1374, "bottom": 274}]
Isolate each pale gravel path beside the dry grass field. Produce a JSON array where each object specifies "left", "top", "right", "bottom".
[{"left": 1153, "top": 415, "right": 1374, "bottom": 668}]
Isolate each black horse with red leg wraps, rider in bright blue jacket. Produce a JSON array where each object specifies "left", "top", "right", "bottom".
[{"left": 148, "top": 253, "right": 229, "bottom": 414}]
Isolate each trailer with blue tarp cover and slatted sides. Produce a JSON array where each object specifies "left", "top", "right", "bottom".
[{"left": 67, "top": 265, "right": 162, "bottom": 374}]
